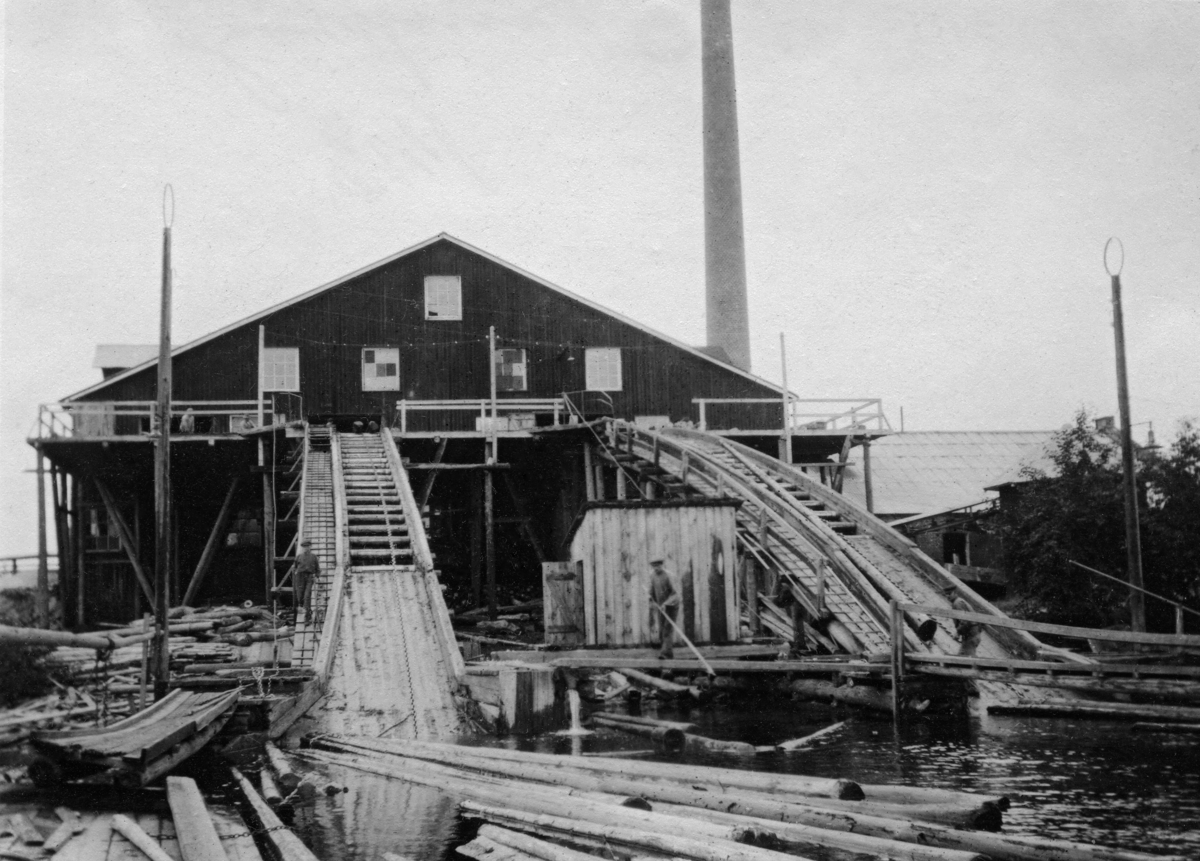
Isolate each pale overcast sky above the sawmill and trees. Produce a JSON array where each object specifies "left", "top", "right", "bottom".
[{"left": 0, "top": 0, "right": 1200, "bottom": 554}]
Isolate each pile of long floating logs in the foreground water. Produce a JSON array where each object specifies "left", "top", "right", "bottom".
[{"left": 301, "top": 736, "right": 1180, "bottom": 861}]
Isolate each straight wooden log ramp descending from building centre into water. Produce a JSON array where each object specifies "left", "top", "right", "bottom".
[{"left": 297, "top": 429, "right": 463, "bottom": 739}]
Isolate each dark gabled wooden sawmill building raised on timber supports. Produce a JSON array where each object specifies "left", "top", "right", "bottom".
[{"left": 30, "top": 234, "right": 888, "bottom": 626}]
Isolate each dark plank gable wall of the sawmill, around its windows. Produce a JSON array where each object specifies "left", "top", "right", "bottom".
[{"left": 79, "top": 240, "right": 779, "bottom": 427}]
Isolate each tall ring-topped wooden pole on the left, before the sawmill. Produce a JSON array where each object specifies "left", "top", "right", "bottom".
[{"left": 154, "top": 185, "right": 175, "bottom": 699}]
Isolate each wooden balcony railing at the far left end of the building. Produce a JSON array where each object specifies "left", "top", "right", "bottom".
[{"left": 34, "top": 401, "right": 278, "bottom": 440}]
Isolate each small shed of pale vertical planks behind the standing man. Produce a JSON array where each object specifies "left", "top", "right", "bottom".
[{"left": 544, "top": 499, "right": 740, "bottom": 646}]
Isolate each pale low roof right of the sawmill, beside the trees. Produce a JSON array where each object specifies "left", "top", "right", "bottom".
[{"left": 842, "top": 431, "right": 1056, "bottom": 517}]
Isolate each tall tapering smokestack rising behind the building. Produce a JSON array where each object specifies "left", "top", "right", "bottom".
[{"left": 700, "top": 0, "right": 750, "bottom": 371}]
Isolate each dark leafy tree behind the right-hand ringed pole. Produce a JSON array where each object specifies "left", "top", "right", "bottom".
[{"left": 996, "top": 411, "right": 1200, "bottom": 631}]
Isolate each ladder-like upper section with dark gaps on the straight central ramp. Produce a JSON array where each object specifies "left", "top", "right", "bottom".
[{"left": 338, "top": 433, "right": 413, "bottom": 567}]
